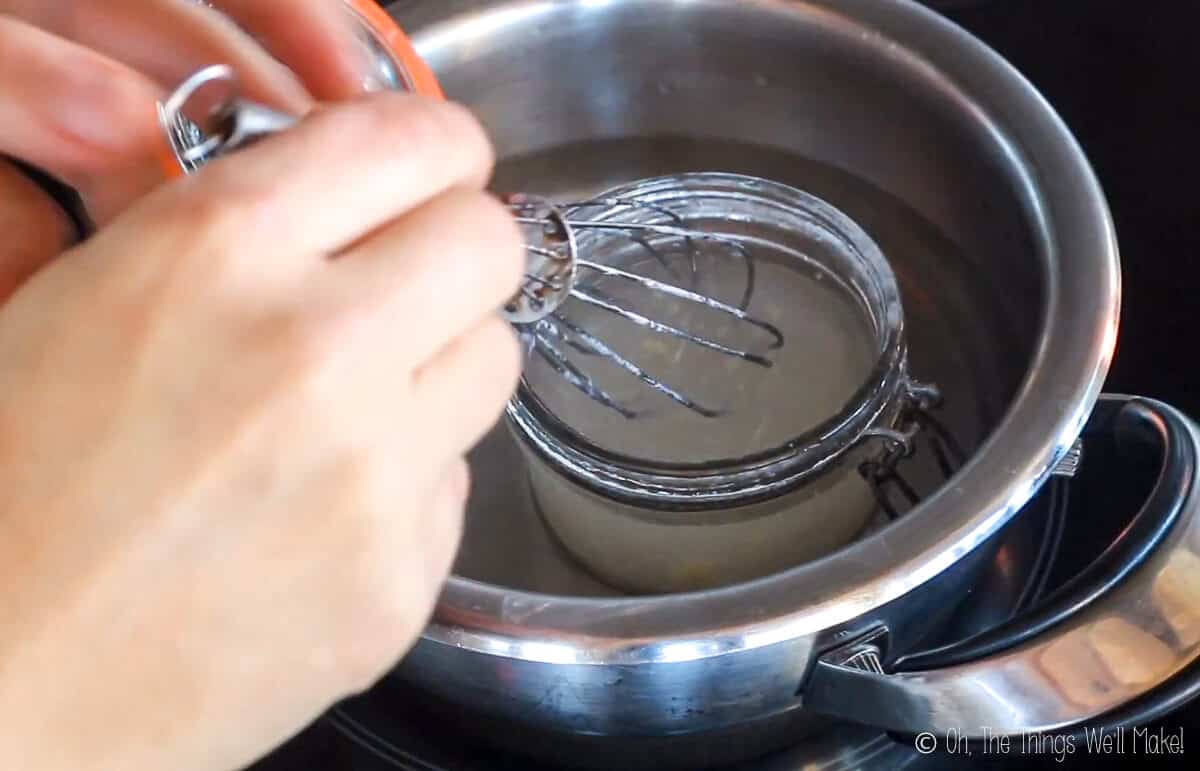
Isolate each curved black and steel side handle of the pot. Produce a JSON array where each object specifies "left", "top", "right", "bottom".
[{"left": 803, "top": 395, "right": 1200, "bottom": 741}]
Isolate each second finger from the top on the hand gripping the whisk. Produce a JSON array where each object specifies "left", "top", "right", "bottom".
[{"left": 318, "top": 190, "right": 524, "bottom": 364}]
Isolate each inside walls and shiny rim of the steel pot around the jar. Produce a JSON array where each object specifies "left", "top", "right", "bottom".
[{"left": 392, "top": 0, "right": 1118, "bottom": 648}]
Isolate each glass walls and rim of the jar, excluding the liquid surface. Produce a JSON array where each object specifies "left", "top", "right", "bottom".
[{"left": 509, "top": 174, "right": 908, "bottom": 594}]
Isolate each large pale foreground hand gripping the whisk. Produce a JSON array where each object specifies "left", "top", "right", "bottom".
[{"left": 0, "top": 94, "right": 523, "bottom": 771}]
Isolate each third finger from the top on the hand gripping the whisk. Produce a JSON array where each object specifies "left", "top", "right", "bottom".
[{"left": 413, "top": 317, "right": 521, "bottom": 454}]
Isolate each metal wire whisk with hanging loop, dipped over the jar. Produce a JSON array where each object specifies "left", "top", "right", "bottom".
[{"left": 158, "top": 65, "right": 784, "bottom": 418}]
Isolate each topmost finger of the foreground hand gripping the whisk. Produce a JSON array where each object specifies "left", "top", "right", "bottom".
[{"left": 166, "top": 94, "right": 492, "bottom": 264}]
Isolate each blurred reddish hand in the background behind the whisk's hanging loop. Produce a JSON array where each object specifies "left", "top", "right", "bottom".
[{"left": 0, "top": 0, "right": 403, "bottom": 301}]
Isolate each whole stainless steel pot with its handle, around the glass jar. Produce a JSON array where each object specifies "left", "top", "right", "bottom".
[{"left": 379, "top": 0, "right": 1200, "bottom": 758}]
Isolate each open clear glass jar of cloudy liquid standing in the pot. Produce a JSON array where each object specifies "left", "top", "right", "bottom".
[{"left": 508, "top": 174, "right": 925, "bottom": 593}]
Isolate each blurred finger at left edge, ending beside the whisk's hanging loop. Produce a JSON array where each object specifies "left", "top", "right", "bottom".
[{"left": 0, "top": 15, "right": 161, "bottom": 222}]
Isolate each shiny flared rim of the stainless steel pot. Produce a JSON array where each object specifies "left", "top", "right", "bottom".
[{"left": 414, "top": 0, "right": 1121, "bottom": 665}]
